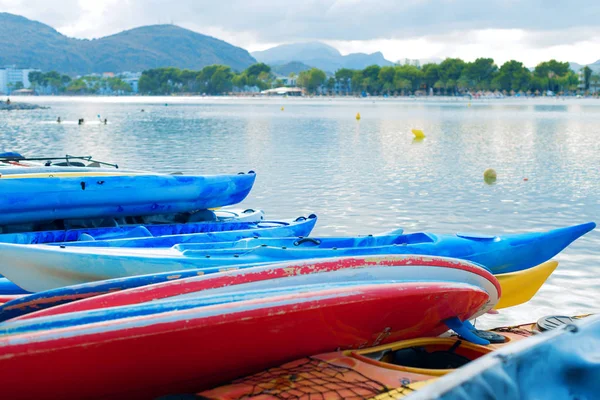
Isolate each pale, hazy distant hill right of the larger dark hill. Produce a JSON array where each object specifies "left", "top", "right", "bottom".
[{"left": 252, "top": 42, "right": 394, "bottom": 73}]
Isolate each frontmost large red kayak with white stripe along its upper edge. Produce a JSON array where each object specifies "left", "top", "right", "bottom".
[{"left": 0, "top": 269, "right": 498, "bottom": 399}]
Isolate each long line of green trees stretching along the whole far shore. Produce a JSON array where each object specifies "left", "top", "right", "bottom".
[{"left": 21, "top": 58, "right": 600, "bottom": 95}]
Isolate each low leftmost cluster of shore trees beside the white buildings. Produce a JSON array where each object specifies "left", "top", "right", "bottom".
[{"left": 29, "top": 71, "right": 132, "bottom": 94}]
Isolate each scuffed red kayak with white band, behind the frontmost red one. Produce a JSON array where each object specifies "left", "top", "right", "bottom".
[{"left": 12, "top": 255, "right": 500, "bottom": 321}]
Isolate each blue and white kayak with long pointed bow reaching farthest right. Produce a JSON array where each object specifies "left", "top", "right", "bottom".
[{"left": 0, "top": 222, "right": 596, "bottom": 292}]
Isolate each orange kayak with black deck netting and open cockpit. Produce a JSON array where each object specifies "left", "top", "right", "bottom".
[{"left": 198, "top": 316, "right": 579, "bottom": 400}]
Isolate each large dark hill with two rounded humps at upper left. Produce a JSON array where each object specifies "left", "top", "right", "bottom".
[{"left": 0, "top": 13, "right": 256, "bottom": 75}]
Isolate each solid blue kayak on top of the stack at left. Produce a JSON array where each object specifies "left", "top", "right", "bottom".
[{"left": 0, "top": 168, "right": 256, "bottom": 225}]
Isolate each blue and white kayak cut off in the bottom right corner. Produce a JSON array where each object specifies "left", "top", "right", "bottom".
[{"left": 410, "top": 316, "right": 600, "bottom": 400}]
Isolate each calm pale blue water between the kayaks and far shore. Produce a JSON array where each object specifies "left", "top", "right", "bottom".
[{"left": 0, "top": 97, "right": 600, "bottom": 326}]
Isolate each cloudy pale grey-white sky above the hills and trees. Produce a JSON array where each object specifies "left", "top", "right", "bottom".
[{"left": 0, "top": 0, "right": 600, "bottom": 66}]
